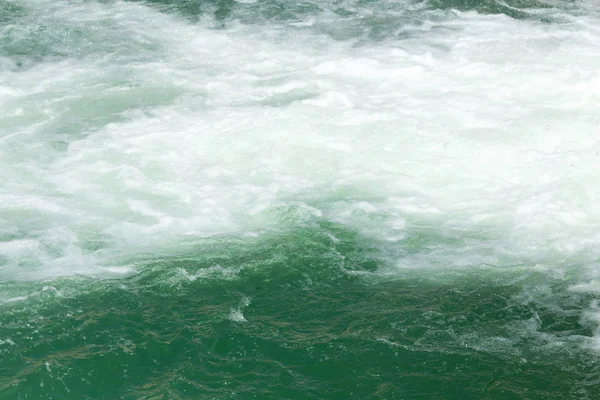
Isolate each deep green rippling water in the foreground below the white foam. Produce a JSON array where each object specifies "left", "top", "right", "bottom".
[{"left": 0, "top": 228, "right": 600, "bottom": 399}]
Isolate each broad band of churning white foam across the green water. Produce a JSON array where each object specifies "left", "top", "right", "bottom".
[{"left": 0, "top": 0, "right": 600, "bottom": 346}]
